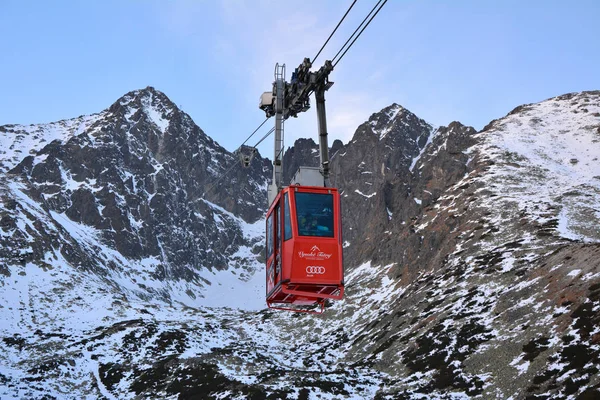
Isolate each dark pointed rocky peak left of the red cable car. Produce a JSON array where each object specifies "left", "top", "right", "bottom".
[{"left": 0, "top": 87, "right": 269, "bottom": 280}]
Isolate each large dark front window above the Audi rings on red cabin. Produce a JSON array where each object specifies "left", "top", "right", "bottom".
[{"left": 295, "top": 192, "right": 333, "bottom": 237}]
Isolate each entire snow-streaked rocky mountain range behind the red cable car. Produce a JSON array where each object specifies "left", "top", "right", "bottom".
[{"left": 0, "top": 88, "right": 600, "bottom": 399}]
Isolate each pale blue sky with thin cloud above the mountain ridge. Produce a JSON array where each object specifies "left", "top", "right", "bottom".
[{"left": 0, "top": 0, "right": 600, "bottom": 157}]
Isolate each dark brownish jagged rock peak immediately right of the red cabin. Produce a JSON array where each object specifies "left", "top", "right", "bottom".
[{"left": 276, "top": 104, "right": 476, "bottom": 290}]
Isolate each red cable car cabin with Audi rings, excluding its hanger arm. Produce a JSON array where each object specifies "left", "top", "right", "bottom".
[{"left": 266, "top": 186, "right": 344, "bottom": 313}]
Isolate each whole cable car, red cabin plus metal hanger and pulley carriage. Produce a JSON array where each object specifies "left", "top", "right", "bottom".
[{"left": 259, "top": 58, "right": 344, "bottom": 313}]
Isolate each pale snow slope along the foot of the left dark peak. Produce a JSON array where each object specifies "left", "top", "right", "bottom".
[{"left": 0, "top": 164, "right": 264, "bottom": 310}]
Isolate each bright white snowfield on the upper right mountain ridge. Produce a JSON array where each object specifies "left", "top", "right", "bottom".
[{"left": 473, "top": 92, "right": 600, "bottom": 242}]
